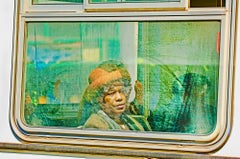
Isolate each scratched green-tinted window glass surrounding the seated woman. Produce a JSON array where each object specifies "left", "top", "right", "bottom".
[{"left": 21, "top": 21, "right": 220, "bottom": 134}]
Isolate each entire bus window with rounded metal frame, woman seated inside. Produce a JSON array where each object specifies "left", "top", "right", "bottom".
[{"left": 11, "top": 0, "right": 235, "bottom": 155}]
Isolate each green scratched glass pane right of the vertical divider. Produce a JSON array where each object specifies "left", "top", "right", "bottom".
[{"left": 138, "top": 21, "right": 220, "bottom": 134}]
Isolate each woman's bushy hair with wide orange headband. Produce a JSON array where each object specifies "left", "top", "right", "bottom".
[{"left": 78, "top": 60, "right": 131, "bottom": 125}]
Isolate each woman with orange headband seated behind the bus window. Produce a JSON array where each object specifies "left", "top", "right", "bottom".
[{"left": 80, "top": 61, "right": 151, "bottom": 131}]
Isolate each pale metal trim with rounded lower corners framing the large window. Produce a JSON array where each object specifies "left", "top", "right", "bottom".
[{"left": 10, "top": 1, "right": 235, "bottom": 152}]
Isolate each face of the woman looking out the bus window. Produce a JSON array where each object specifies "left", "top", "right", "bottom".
[{"left": 101, "top": 83, "right": 127, "bottom": 117}]
